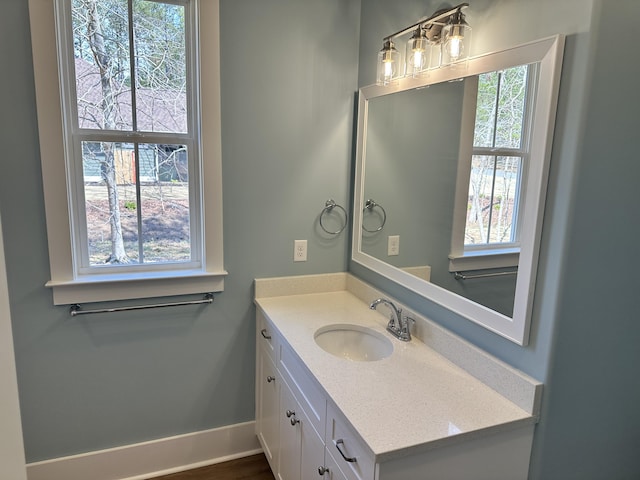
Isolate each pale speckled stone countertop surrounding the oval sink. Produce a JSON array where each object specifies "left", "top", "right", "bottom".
[{"left": 255, "top": 277, "right": 541, "bottom": 461}]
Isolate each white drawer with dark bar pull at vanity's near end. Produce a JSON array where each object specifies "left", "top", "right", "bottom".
[{"left": 325, "top": 402, "right": 375, "bottom": 480}]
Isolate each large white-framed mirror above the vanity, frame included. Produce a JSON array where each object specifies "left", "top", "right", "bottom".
[{"left": 353, "top": 36, "right": 563, "bottom": 344}]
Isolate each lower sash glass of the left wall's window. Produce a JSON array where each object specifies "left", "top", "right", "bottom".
[{"left": 82, "top": 142, "right": 191, "bottom": 266}]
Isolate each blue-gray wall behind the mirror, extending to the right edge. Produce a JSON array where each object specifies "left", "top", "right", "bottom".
[{"left": 350, "top": 0, "right": 640, "bottom": 480}]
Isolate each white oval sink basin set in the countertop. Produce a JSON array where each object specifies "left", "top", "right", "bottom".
[{"left": 314, "top": 324, "right": 393, "bottom": 362}]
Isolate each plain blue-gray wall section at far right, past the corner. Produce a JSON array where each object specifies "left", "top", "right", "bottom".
[{"left": 533, "top": 0, "right": 640, "bottom": 479}]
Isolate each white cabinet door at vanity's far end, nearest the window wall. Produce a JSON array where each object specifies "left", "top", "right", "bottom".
[{"left": 256, "top": 348, "right": 280, "bottom": 472}]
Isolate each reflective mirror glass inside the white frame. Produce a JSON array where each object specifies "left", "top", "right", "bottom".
[{"left": 362, "top": 65, "right": 536, "bottom": 317}]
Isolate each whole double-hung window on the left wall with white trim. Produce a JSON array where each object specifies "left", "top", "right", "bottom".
[{"left": 30, "top": 0, "right": 226, "bottom": 304}]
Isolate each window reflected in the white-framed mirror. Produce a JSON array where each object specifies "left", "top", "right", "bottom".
[{"left": 450, "top": 65, "right": 535, "bottom": 270}]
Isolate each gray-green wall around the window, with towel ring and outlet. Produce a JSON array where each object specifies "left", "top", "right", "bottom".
[{"left": 0, "top": 0, "right": 360, "bottom": 462}]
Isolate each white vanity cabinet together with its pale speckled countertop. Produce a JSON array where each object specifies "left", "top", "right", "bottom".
[{"left": 256, "top": 282, "right": 539, "bottom": 480}]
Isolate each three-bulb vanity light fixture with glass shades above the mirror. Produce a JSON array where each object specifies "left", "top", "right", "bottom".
[{"left": 377, "top": 3, "right": 471, "bottom": 85}]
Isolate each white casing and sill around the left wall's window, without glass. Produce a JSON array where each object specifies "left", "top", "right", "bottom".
[{"left": 29, "top": 0, "right": 227, "bottom": 305}]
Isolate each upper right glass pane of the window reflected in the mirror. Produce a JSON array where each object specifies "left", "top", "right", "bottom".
[{"left": 494, "top": 65, "right": 528, "bottom": 148}]
